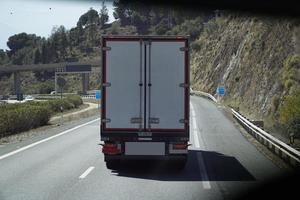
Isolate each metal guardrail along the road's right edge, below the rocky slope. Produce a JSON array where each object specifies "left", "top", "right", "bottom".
[{"left": 191, "top": 90, "right": 300, "bottom": 168}]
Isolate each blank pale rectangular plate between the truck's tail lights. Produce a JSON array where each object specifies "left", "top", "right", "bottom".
[{"left": 125, "top": 142, "right": 165, "bottom": 155}]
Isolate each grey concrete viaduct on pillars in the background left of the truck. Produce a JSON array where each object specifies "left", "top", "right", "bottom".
[{"left": 0, "top": 58, "right": 101, "bottom": 95}]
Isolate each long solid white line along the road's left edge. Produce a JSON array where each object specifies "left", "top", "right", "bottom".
[{"left": 0, "top": 118, "right": 100, "bottom": 160}]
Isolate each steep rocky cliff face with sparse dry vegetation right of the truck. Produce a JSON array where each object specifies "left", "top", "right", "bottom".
[{"left": 191, "top": 14, "right": 300, "bottom": 133}]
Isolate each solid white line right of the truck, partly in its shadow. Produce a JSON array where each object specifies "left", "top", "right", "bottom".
[{"left": 190, "top": 103, "right": 211, "bottom": 189}]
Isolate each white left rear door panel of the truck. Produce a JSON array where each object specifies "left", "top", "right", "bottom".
[{"left": 105, "top": 41, "right": 144, "bottom": 129}]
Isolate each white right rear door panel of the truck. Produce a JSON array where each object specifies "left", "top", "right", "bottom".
[{"left": 146, "top": 41, "right": 185, "bottom": 129}]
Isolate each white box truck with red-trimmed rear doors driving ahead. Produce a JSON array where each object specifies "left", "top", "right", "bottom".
[{"left": 100, "top": 36, "right": 190, "bottom": 169}]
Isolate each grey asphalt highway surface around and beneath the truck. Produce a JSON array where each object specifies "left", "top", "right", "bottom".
[{"left": 0, "top": 96, "right": 286, "bottom": 200}]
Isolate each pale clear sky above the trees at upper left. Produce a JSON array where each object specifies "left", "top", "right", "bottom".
[{"left": 0, "top": 0, "right": 114, "bottom": 49}]
